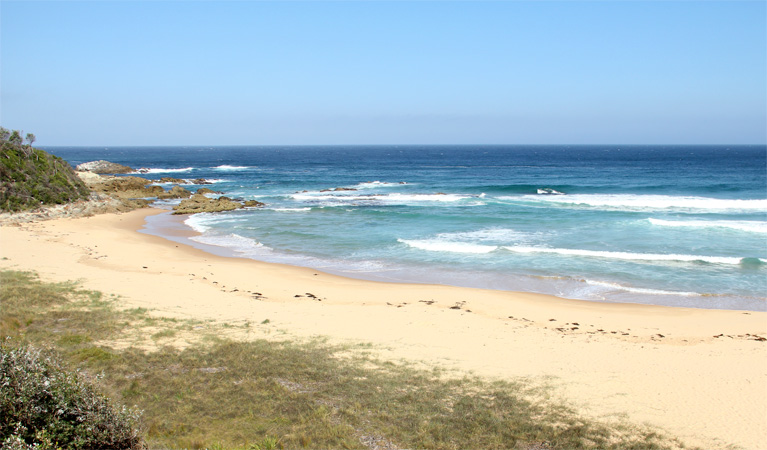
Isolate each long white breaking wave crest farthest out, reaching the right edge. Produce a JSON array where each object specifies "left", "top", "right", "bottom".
[{"left": 510, "top": 194, "right": 767, "bottom": 212}]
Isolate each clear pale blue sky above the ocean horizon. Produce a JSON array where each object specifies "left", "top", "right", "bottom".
[{"left": 0, "top": 0, "right": 767, "bottom": 146}]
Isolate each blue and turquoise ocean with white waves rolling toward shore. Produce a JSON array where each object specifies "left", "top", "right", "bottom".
[{"left": 46, "top": 146, "right": 767, "bottom": 310}]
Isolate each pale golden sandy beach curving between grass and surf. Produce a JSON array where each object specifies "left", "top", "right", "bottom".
[{"left": 0, "top": 209, "right": 767, "bottom": 449}]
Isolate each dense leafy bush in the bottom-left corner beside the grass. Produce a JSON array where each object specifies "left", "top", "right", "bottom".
[{"left": 0, "top": 343, "right": 144, "bottom": 450}]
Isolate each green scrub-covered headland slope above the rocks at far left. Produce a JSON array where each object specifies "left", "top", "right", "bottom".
[{"left": 0, "top": 127, "right": 90, "bottom": 211}]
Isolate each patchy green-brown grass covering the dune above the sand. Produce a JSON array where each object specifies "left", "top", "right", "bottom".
[{"left": 0, "top": 272, "right": 682, "bottom": 450}]
